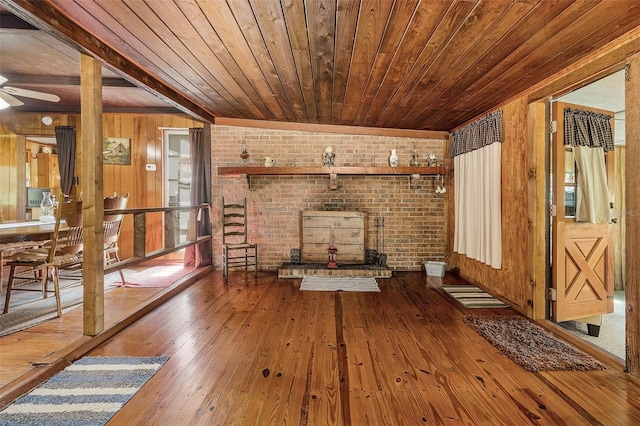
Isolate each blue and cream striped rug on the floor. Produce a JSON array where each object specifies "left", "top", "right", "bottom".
[{"left": 0, "top": 356, "right": 168, "bottom": 426}]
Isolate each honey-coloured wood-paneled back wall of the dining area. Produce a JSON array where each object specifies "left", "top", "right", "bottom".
[{"left": 0, "top": 112, "right": 202, "bottom": 258}]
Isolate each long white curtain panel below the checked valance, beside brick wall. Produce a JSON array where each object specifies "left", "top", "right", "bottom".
[{"left": 453, "top": 143, "right": 502, "bottom": 269}]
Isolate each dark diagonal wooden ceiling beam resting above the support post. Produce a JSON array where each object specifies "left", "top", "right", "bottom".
[{"left": 0, "top": 0, "right": 216, "bottom": 123}]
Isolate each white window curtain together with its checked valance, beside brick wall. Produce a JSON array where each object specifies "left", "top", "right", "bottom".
[{"left": 451, "top": 111, "right": 502, "bottom": 269}]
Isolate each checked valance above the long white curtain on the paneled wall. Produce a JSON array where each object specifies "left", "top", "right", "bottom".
[{"left": 451, "top": 110, "right": 502, "bottom": 157}]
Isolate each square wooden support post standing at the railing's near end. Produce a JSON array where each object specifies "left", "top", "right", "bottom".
[{"left": 80, "top": 54, "right": 104, "bottom": 336}]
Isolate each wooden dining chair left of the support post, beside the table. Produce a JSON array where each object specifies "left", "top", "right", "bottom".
[{"left": 3, "top": 201, "right": 83, "bottom": 316}]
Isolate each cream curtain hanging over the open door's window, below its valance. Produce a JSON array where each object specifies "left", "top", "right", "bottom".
[{"left": 573, "top": 146, "right": 611, "bottom": 223}]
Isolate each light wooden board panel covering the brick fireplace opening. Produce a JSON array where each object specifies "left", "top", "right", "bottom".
[{"left": 300, "top": 211, "right": 366, "bottom": 264}]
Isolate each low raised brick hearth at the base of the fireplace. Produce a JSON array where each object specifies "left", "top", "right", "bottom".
[{"left": 278, "top": 263, "right": 392, "bottom": 278}]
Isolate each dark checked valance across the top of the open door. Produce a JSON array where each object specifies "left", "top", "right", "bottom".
[{"left": 564, "top": 108, "right": 614, "bottom": 151}]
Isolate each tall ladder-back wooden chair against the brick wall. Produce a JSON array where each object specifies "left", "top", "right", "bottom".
[{"left": 222, "top": 197, "right": 258, "bottom": 282}]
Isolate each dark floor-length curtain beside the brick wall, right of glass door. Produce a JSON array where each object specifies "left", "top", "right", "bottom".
[{"left": 184, "top": 126, "right": 213, "bottom": 268}]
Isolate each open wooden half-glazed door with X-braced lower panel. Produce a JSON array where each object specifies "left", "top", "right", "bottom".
[{"left": 551, "top": 102, "right": 614, "bottom": 321}]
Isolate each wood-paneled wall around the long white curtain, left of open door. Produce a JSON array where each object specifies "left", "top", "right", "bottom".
[{"left": 449, "top": 98, "right": 533, "bottom": 312}]
